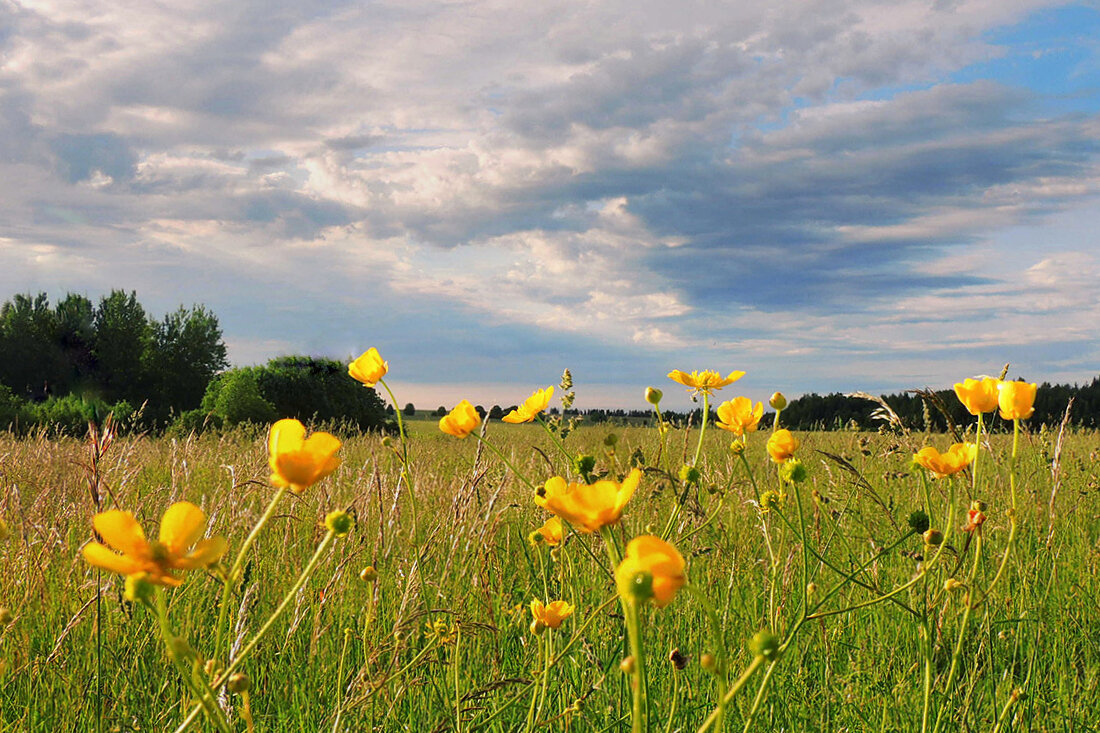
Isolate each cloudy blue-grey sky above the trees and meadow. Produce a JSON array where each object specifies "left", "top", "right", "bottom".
[{"left": 0, "top": 0, "right": 1100, "bottom": 407}]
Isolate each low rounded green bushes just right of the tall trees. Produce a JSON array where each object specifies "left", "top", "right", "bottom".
[{"left": 202, "top": 357, "right": 388, "bottom": 430}]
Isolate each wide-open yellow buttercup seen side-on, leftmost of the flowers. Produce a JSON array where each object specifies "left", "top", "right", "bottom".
[{"left": 84, "top": 502, "right": 227, "bottom": 586}]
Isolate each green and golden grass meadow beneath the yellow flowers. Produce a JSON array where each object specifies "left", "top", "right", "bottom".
[{"left": 0, "top": 402, "right": 1100, "bottom": 732}]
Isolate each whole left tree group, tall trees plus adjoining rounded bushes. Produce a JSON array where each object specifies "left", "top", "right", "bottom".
[{"left": 0, "top": 291, "right": 388, "bottom": 436}]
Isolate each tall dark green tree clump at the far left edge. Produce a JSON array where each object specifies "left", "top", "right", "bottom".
[{"left": 0, "top": 291, "right": 228, "bottom": 428}]
